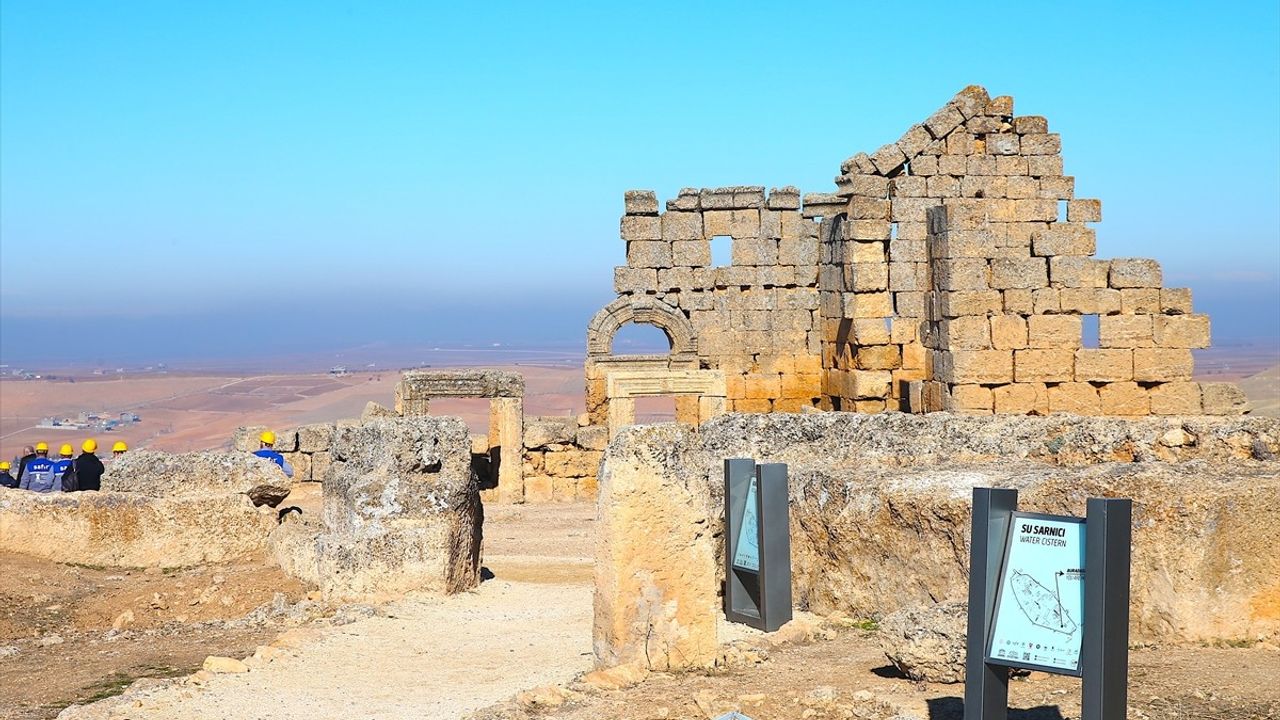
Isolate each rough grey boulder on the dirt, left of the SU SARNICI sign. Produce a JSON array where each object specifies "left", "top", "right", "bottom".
[{"left": 879, "top": 602, "right": 969, "bottom": 683}]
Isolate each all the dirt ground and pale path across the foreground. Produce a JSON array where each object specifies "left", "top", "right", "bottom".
[{"left": 0, "top": 499, "right": 1280, "bottom": 720}]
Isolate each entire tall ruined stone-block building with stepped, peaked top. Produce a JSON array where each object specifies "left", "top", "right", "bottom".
[{"left": 596, "top": 86, "right": 1247, "bottom": 424}]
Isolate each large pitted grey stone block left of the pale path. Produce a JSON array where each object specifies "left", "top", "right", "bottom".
[{"left": 314, "top": 416, "right": 481, "bottom": 600}]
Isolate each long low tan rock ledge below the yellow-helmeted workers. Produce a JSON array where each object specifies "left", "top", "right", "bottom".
[{"left": 0, "top": 486, "right": 275, "bottom": 568}]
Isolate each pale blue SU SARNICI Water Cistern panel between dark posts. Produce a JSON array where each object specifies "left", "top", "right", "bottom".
[{"left": 987, "top": 512, "right": 1084, "bottom": 675}]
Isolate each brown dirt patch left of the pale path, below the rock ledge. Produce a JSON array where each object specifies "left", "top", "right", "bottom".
[{"left": 0, "top": 545, "right": 306, "bottom": 719}]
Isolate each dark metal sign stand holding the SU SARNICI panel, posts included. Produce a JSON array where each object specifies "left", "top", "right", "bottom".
[{"left": 964, "top": 488, "right": 1133, "bottom": 720}]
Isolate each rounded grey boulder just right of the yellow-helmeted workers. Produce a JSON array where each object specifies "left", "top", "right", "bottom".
[{"left": 102, "top": 450, "right": 293, "bottom": 507}]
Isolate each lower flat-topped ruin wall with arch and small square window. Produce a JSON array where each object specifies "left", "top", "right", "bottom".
[{"left": 588, "top": 186, "right": 837, "bottom": 424}]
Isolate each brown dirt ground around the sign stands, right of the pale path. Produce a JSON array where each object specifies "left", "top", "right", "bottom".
[{"left": 481, "top": 626, "right": 1280, "bottom": 720}]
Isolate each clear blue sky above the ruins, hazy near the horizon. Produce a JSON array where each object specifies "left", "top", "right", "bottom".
[{"left": 0, "top": 0, "right": 1280, "bottom": 361}]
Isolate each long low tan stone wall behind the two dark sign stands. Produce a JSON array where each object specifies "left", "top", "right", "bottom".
[{"left": 596, "top": 413, "right": 1280, "bottom": 666}]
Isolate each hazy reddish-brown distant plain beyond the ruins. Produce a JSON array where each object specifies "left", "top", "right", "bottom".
[{"left": 0, "top": 346, "right": 1280, "bottom": 457}]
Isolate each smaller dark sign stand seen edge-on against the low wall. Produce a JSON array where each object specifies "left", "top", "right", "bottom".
[{"left": 724, "top": 457, "right": 791, "bottom": 632}]
